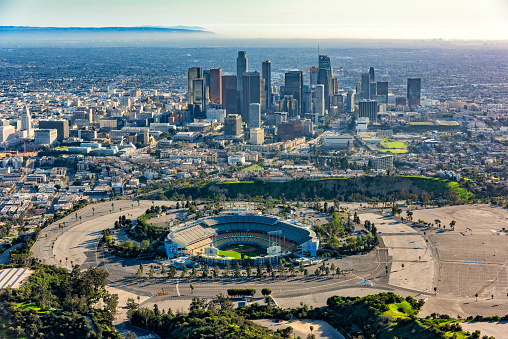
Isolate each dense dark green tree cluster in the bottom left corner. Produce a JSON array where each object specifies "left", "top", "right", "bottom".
[{"left": 0, "top": 265, "right": 120, "bottom": 338}]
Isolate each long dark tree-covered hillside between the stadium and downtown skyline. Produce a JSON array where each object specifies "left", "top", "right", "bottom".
[{"left": 165, "top": 176, "right": 472, "bottom": 202}]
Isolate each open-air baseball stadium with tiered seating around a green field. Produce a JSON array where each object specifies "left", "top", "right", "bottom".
[{"left": 165, "top": 210, "right": 319, "bottom": 263}]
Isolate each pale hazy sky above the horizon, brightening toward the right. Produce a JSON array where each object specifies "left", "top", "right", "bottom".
[{"left": 0, "top": 0, "right": 508, "bottom": 40}]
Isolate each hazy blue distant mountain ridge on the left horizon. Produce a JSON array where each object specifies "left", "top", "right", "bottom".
[{"left": 0, "top": 26, "right": 211, "bottom": 33}]
